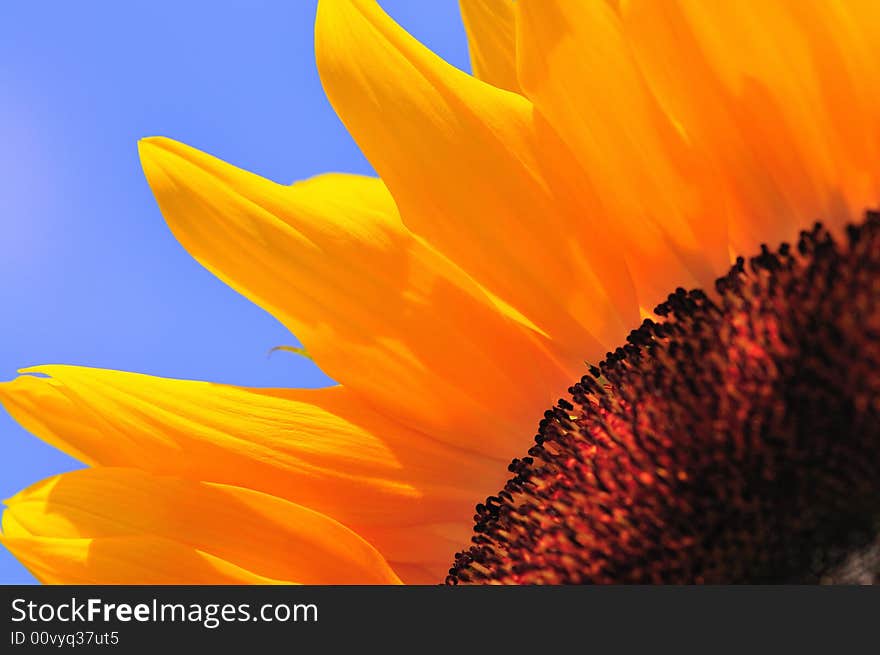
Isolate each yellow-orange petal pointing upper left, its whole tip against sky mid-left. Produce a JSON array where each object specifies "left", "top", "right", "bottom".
[{"left": 140, "top": 139, "right": 572, "bottom": 459}]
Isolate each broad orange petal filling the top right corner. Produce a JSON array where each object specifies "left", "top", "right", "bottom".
[{"left": 623, "top": 0, "right": 880, "bottom": 252}]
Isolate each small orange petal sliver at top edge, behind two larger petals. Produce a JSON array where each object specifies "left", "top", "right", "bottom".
[{"left": 458, "top": 0, "right": 520, "bottom": 93}]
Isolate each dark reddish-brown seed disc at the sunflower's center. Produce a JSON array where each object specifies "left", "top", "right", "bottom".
[{"left": 447, "top": 212, "right": 880, "bottom": 584}]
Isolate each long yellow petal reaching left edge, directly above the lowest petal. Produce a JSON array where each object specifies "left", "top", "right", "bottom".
[{"left": 0, "top": 366, "right": 498, "bottom": 581}]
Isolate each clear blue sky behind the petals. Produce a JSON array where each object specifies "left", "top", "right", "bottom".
[{"left": 0, "top": 0, "right": 468, "bottom": 584}]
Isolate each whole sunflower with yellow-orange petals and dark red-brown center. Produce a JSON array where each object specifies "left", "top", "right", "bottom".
[{"left": 0, "top": 0, "right": 880, "bottom": 584}]
